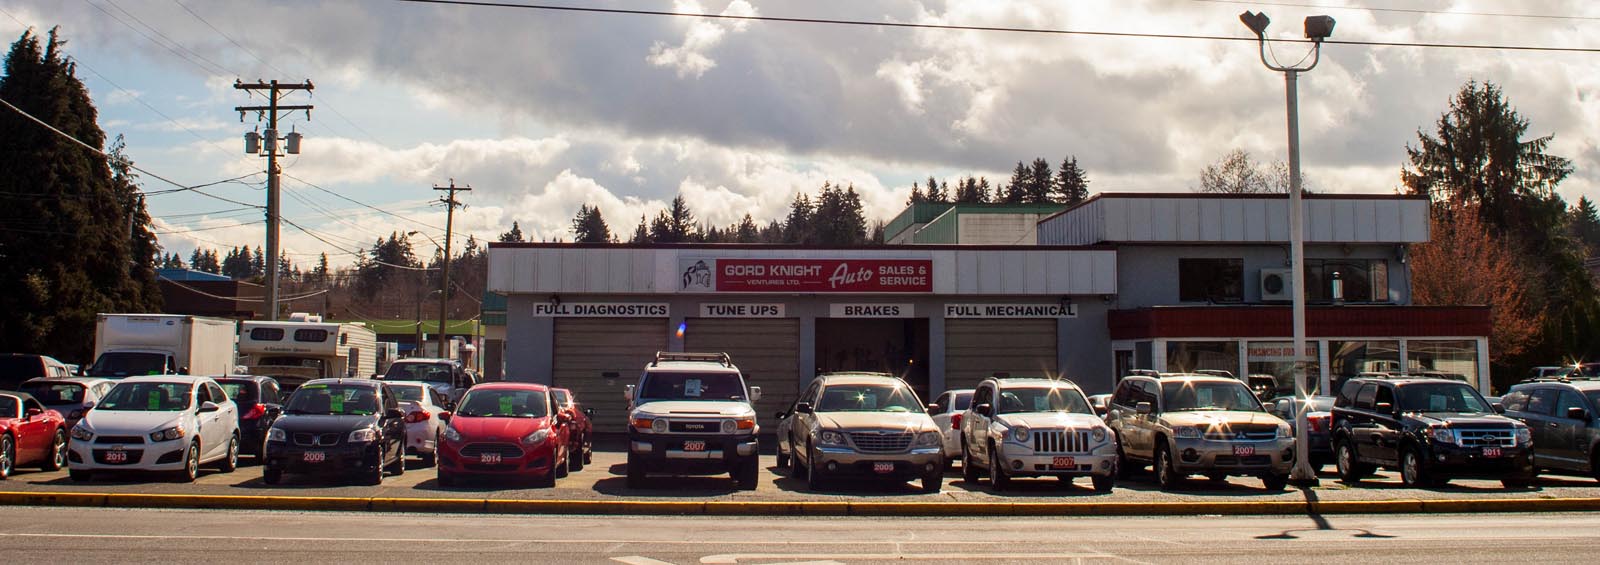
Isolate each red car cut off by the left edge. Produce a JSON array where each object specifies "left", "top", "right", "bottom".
[{"left": 0, "top": 391, "right": 67, "bottom": 480}]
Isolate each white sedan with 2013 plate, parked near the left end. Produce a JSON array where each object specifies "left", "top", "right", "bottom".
[{"left": 67, "top": 375, "right": 240, "bottom": 482}]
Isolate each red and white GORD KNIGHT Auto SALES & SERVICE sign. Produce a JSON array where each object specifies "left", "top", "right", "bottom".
[{"left": 678, "top": 258, "right": 933, "bottom": 293}]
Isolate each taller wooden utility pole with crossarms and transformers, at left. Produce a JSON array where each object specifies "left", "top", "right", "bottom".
[{"left": 234, "top": 80, "right": 314, "bottom": 320}]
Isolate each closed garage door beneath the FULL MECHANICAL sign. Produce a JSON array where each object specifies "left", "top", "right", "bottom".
[{"left": 944, "top": 319, "right": 1056, "bottom": 391}]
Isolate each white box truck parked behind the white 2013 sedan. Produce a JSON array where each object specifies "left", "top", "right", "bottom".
[{"left": 86, "top": 314, "right": 238, "bottom": 378}]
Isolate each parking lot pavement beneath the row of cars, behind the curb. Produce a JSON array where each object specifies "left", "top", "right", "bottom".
[{"left": 9, "top": 441, "right": 1600, "bottom": 503}]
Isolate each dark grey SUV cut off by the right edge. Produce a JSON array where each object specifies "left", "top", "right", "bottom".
[{"left": 1501, "top": 381, "right": 1600, "bottom": 480}]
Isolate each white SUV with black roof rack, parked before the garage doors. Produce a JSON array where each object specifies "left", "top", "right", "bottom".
[{"left": 624, "top": 352, "right": 762, "bottom": 490}]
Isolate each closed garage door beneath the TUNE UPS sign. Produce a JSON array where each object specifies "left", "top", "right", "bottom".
[{"left": 683, "top": 319, "right": 803, "bottom": 432}]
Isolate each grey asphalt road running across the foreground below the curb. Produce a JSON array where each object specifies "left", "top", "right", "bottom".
[{"left": 0, "top": 507, "right": 1600, "bottom": 565}]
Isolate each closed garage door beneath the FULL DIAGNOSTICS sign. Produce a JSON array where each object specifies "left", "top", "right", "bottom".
[{"left": 554, "top": 319, "right": 667, "bottom": 432}]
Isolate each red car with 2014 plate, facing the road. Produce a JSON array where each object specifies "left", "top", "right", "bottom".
[{"left": 438, "top": 383, "right": 571, "bottom": 487}]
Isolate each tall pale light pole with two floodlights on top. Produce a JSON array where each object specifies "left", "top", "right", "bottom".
[{"left": 1238, "top": 11, "right": 1334, "bottom": 485}]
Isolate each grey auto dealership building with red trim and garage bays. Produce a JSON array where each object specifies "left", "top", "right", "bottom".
[{"left": 488, "top": 194, "right": 1490, "bottom": 431}]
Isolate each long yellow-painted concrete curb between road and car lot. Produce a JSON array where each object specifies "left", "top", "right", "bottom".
[{"left": 9, "top": 491, "right": 1600, "bottom": 517}]
